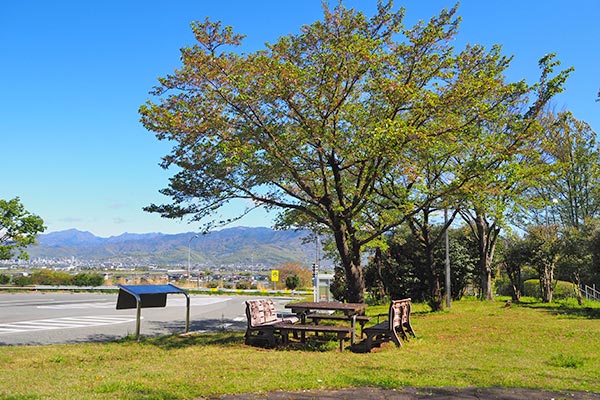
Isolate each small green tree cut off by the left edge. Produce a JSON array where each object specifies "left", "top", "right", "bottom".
[{"left": 0, "top": 197, "right": 45, "bottom": 260}]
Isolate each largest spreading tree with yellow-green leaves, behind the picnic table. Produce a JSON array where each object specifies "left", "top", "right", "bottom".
[{"left": 140, "top": 2, "right": 568, "bottom": 302}]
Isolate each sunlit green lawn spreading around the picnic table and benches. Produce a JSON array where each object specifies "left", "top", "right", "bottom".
[{"left": 0, "top": 300, "right": 600, "bottom": 399}]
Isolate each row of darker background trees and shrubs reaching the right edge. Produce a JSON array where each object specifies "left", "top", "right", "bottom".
[{"left": 346, "top": 112, "right": 600, "bottom": 308}]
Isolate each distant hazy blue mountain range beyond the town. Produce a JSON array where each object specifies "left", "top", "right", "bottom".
[{"left": 27, "top": 227, "right": 315, "bottom": 266}]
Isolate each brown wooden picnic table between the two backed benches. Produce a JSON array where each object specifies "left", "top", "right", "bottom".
[{"left": 285, "top": 301, "right": 367, "bottom": 344}]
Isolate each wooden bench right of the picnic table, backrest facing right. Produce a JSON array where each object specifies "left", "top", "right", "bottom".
[{"left": 363, "top": 299, "right": 416, "bottom": 351}]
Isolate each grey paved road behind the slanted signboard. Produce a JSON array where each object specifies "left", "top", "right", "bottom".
[{"left": 0, "top": 292, "right": 290, "bottom": 345}]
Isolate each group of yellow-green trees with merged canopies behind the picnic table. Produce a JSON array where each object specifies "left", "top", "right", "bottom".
[{"left": 140, "top": 1, "right": 591, "bottom": 309}]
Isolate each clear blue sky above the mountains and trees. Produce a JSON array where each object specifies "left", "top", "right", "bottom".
[{"left": 0, "top": 0, "right": 600, "bottom": 237}]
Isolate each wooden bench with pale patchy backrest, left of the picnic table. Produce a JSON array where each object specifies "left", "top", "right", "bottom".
[{"left": 244, "top": 299, "right": 299, "bottom": 347}]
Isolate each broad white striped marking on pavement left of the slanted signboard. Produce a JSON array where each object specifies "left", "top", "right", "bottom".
[{"left": 0, "top": 315, "right": 135, "bottom": 335}]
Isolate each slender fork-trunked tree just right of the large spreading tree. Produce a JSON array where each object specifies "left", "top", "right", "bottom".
[{"left": 460, "top": 54, "right": 573, "bottom": 300}]
